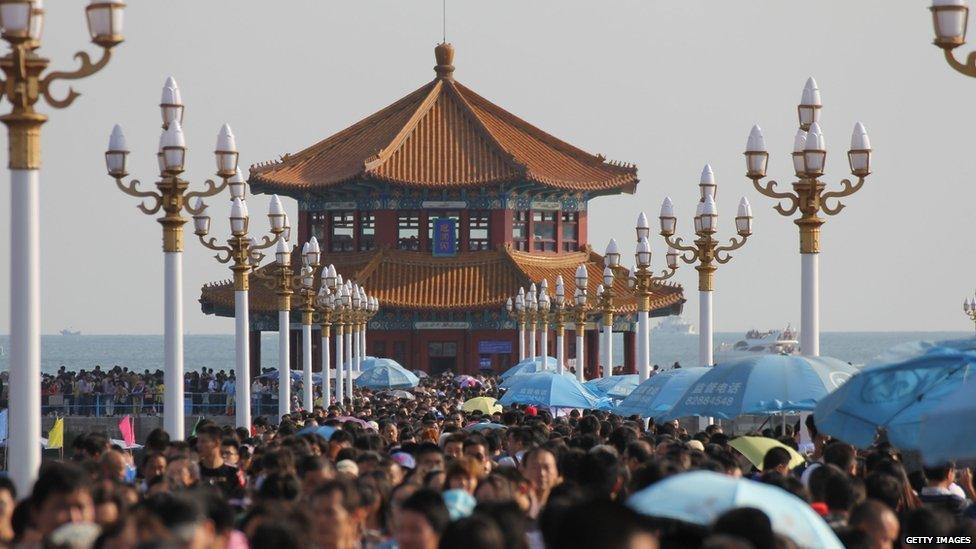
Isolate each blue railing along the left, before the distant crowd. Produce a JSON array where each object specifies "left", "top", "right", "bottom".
[{"left": 29, "top": 392, "right": 294, "bottom": 417}]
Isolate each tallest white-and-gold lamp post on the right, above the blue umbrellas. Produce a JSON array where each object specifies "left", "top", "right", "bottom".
[{"left": 745, "top": 78, "right": 871, "bottom": 356}]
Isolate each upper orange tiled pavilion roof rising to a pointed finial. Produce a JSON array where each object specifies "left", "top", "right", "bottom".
[{"left": 249, "top": 44, "right": 638, "bottom": 194}]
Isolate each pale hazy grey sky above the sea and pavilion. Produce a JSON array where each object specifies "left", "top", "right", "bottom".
[{"left": 0, "top": 0, "right": 976, "bottom": 334}]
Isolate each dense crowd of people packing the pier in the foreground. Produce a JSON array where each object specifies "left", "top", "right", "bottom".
[{"left": 0, "top": 370, "right": 976, "bottom": 549}]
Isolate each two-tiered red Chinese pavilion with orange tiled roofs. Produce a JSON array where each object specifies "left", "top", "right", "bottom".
[{"left": 200, "top": 44, "right": 684, "bottom": 377}]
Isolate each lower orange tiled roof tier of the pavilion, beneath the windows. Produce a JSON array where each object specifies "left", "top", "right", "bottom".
[{"left": 200, "top": 247, "right": 684, "bottom": 316}]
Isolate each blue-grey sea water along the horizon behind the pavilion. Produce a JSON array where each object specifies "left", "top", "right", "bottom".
[{"left": 0, "top": 332, "right": 972, "bottom": 373}]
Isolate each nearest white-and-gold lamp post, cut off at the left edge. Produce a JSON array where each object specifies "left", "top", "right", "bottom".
[{"left": 0, "top": 0, "right": 125, "bottom": 493}]
